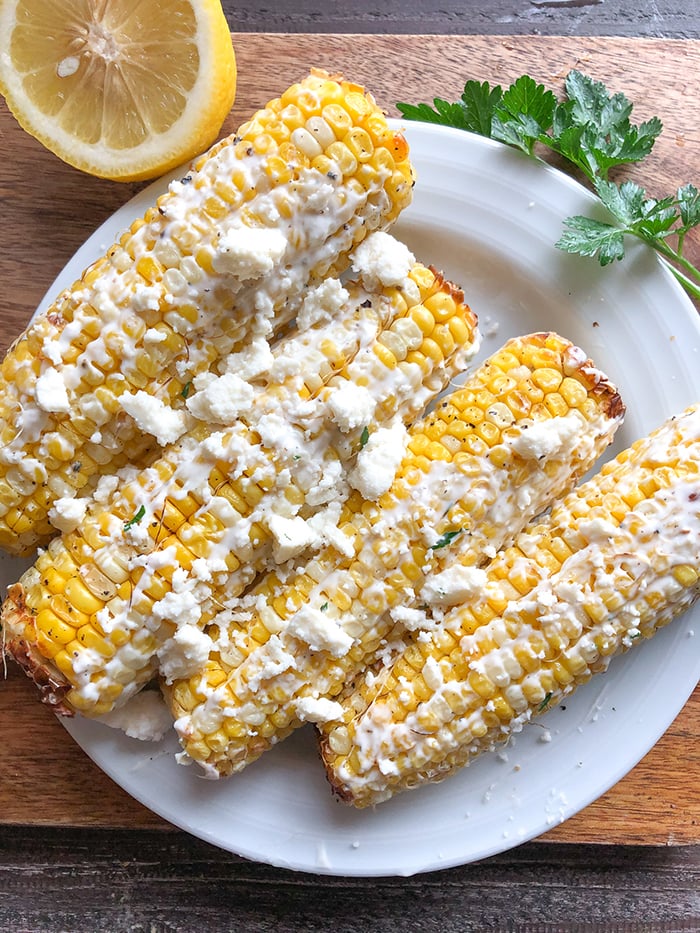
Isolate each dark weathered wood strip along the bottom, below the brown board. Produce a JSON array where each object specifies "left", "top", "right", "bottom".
[{"left": 0, "top": 827, "right": 700, "bottom": 933}]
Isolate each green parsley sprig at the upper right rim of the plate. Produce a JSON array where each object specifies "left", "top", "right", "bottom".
[{"left": 397, "top": 70, "right": 700, "bottom": 298}]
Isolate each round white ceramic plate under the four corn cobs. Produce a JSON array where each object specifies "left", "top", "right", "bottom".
[{"left": 3, "top": 124, "right": 700, "bottom": 875}]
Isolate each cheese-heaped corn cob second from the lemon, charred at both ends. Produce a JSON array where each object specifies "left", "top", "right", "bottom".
[{"left": 2, "top": 258, "right": 476, "bottom": 715}]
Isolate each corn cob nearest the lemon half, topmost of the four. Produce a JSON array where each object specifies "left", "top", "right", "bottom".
[{"left": 0, "top": 73, "right": 412, "bottom": 554}]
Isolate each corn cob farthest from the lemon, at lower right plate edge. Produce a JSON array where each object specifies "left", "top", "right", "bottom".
[{"left": 321, "top": 406, "right": 700, "bottom": 807}]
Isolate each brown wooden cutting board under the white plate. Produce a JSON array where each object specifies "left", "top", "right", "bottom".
[{"left": 0, "top": 34, "right": 700, "bottom": 845}]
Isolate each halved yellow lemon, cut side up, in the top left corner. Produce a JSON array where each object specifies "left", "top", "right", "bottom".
[{"left": 0, "top": 0, "right": 236, "bottom": 181}]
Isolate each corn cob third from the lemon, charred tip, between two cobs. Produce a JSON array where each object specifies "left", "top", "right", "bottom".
[{"left": 167, "top": 334, "right": 623, "bottom": 774}]
